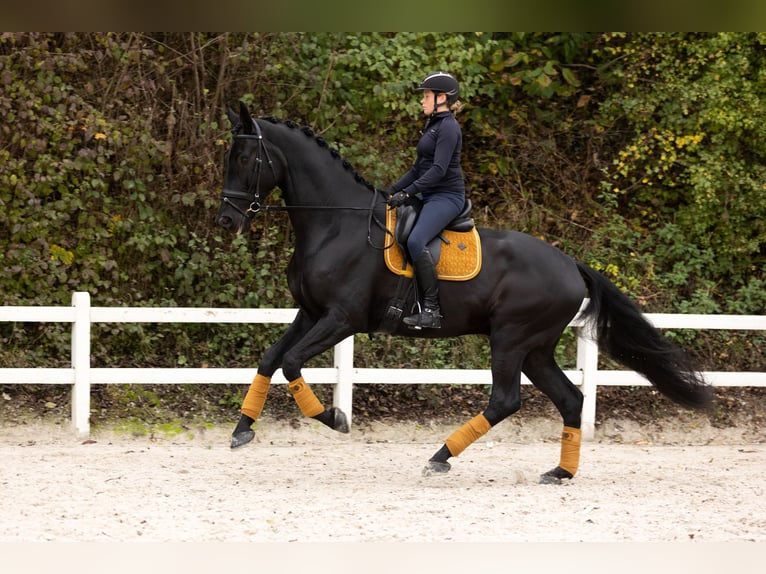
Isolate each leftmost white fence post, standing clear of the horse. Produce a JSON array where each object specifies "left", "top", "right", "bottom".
[{"left": 72, "top": 291, "right": 90, "bottom": 436}]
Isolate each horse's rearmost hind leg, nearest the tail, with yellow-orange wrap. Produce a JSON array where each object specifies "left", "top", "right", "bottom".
[{"left": 523, "top": 349, "right": 583, "bottom": 484}]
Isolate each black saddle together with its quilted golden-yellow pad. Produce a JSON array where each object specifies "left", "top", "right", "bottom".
[{"left": 385, "top": 198, "right": 481, "bottom": 281}]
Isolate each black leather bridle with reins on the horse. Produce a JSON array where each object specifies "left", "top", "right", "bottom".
[{"left": 221, "top": 120, "right": 396, "bottom": 250}]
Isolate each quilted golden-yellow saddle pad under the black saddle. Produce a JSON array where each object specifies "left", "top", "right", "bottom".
[{"left": 383, "top": 208, "right": 481, "bottom": 281}]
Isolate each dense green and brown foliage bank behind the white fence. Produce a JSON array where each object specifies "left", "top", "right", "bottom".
[{"left": 0, "top": 32, "right": 766, "bottom": 426}]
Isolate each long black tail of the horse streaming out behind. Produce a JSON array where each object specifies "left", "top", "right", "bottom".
[{"left": 577, "top": 262, "right": 713, "bottom": 409}]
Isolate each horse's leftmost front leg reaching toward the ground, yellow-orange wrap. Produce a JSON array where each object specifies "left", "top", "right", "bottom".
[{"left": 231, "top": 310, "right": 315, "bottom": 448}]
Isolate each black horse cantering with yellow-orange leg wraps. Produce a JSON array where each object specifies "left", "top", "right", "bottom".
[{"left": 217, "top": 103, "right": 712, "bottom": 482}]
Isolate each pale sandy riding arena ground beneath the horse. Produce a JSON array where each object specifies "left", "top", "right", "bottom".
[{"left": 0, "top": 419, "right": 766, "bottom": 543}]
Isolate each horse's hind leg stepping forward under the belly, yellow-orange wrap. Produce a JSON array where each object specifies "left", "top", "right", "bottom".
[{"left": 423, "top": 342, "right": 523, "bottom": 476}]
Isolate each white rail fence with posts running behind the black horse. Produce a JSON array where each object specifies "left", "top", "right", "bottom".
[{"left": 0, "top": 292, "right": 766, "bottom": 438}]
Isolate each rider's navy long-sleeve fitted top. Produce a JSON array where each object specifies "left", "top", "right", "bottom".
[{"left": 391, "top": 112, "right": 465, "bottom": 205}]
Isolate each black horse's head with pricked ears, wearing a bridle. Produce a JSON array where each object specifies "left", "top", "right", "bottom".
[{"left": 216, "top": 102, "right": 277, "bottom": 233}]
